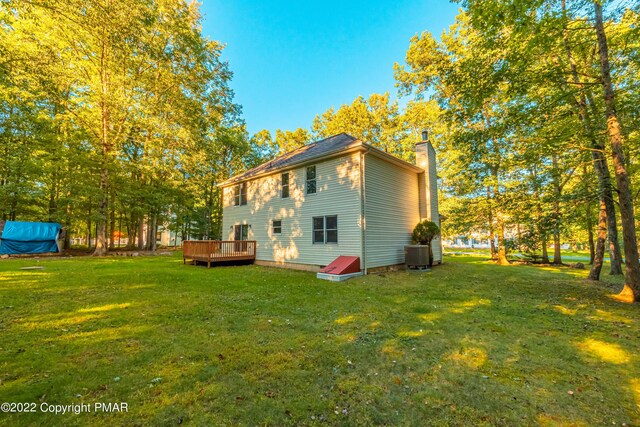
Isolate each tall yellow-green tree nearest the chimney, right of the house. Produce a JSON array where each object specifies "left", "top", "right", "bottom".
[{"left": 396, "top": 13, "right": 515, "bottom": 264}]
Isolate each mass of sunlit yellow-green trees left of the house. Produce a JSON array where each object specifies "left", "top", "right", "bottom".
[{"left": 0, "top": 0, "right": 252, "bottom": 254}]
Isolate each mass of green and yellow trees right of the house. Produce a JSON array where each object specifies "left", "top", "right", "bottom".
[{"left": 396, "top": 0, "right": 638, "bottom": 281}]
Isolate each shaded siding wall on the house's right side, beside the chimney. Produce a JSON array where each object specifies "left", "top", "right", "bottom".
[{"left": 364, "top": 154, "right": 420, "bottom": 268}]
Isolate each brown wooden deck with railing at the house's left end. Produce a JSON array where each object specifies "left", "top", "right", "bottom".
[{"left": 182, "top": 240, "right": 256, "bottom": 267}]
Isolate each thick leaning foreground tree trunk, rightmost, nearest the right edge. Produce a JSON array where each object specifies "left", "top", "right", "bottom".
[{"left": 593, "top": 1, "right": 640, "bottom": 302}]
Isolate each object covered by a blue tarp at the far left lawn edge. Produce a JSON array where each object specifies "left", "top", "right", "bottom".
[{"left": 0, "top": 221, "right": 61, "bottom": 255}]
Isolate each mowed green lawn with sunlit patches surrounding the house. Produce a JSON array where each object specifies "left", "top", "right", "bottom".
[{"left": 0, "top": 255, "right": 640, "bottom": 426}]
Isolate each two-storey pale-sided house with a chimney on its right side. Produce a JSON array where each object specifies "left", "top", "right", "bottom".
[{"left": 219, "top": 133, "right": 442, "bottom": 273}]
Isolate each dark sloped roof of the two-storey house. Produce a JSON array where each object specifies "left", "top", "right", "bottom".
[{"left": 218, "top": 133, "right": 419, "bottom": 187}]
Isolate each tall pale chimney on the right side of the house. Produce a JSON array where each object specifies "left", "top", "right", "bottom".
[{"left": 416, "top": 130, "right": 442, "bottom": 263}]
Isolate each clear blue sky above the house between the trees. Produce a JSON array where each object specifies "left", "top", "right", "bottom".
[{"left": 202, "top": 0, "right": 459, "bottom": 134}]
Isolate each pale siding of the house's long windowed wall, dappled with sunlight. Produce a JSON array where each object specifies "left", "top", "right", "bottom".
[{"left": 222, "top": 153, "right": 362, "bottom": 266}]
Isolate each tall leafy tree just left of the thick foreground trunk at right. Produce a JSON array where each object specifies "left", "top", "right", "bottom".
[{"left": 456, "top": 0, "right": 636, "bottom": 288}]
